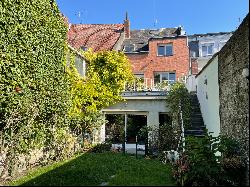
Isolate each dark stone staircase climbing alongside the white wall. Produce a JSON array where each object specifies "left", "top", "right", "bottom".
[{"left": 184, "top": 93, "right": 206, "bottom": 137}]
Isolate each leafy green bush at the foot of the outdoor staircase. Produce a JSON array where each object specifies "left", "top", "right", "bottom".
[{"left": 174, "top": 134, "right": 222, "bottom": 186}]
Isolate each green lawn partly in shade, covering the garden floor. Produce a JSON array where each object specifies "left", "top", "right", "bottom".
[{"left": 8, "top": 152, "right": 176, "bottom": 186}]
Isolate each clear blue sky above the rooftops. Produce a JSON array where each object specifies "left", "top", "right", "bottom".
[{"left": 56, "top": 0, "right": 249, "bottom": 34}]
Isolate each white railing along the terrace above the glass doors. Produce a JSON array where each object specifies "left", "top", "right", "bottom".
[{"left": 124, "top": 78, "right": 174, "bottom": 92}]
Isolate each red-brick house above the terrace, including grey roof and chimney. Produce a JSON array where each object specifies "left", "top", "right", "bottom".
[{"left": 121, "top": 16, "right": 189, "bottom": 87}]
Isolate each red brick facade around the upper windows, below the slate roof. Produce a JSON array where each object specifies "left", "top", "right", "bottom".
[{"left": 126, "top": 37, "right": 189, "bottom": 84}]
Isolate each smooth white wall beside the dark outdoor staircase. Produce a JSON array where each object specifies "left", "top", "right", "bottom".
[{"left": 196, "top": 55, "right": 220, "bottom": 136}]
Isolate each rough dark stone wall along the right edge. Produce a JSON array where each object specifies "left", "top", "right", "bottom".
[{"left": 218, "top": 14, "right": 249, "bottom": 185}]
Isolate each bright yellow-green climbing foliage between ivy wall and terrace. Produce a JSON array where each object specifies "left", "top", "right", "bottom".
[{"left": 67, "top": 49, "right": 133, "bottom": 142}]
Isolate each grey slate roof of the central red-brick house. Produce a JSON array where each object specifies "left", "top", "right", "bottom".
[{"left": 122, "top": 28, "right": 178, "bottom": 52}]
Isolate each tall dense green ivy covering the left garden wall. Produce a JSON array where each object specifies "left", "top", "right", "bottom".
[{"left": 0, "top": 0, "right": 71, "bottom": 177}]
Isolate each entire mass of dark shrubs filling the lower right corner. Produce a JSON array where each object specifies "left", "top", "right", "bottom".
[{"left": 173, "top": 134, "right": 245, "bottom": 186}]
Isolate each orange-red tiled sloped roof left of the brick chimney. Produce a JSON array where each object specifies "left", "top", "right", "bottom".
[{"left": 68, "top": 24, "right": 124, "bottom": 51}]
